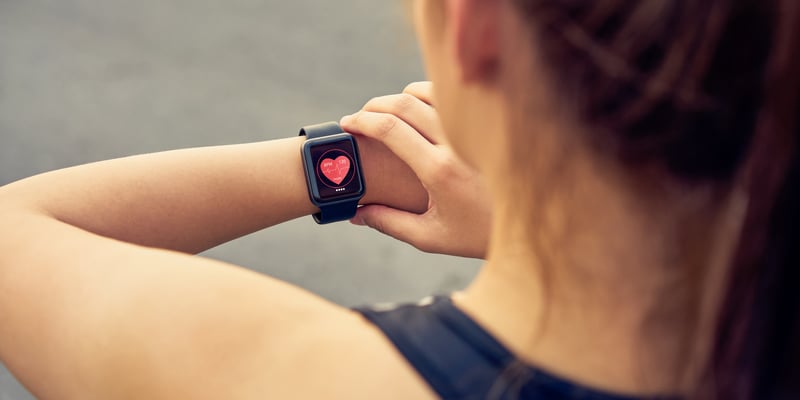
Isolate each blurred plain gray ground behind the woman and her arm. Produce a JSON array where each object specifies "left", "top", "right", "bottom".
[{"left": 0, "top": 0, "right": 479, "bottom": 400}]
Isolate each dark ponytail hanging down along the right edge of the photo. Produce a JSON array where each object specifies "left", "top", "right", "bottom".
[{"left": 698, "top": 0, "right": 800, "bottom": 400}]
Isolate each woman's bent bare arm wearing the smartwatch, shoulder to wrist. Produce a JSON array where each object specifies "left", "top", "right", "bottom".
[{"left": 0, "top": 130, "right": 427, "bottom": 399}]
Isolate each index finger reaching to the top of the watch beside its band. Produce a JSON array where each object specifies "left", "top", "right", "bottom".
[{"left": 340, "top": 111, "right": 442, "bottom": 182}]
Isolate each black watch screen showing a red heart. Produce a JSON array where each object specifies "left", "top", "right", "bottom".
[{"left": 310, "top": 139, "right": 362, "bottom": 200}]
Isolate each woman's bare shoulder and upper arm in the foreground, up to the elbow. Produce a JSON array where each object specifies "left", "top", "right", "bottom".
[{"left": 0, "top": 217, "right": 432, "bottom": 399}]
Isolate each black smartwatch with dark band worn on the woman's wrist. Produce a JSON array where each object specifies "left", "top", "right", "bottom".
[{"left": 300, "top": 122, "right": 365, "bottom": 224}]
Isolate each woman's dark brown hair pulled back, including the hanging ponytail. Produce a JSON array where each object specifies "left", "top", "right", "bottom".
[{"left": 513, "top": 0, "right": 800, "bottom": 400}]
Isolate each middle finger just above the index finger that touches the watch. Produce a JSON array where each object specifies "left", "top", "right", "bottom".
[{"left": 363, "top": 94, "right": 443, "bottom": 144}]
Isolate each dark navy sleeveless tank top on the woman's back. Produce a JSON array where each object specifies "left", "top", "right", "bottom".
[{"left": 356, "top": 297, "right": 668, "bottom": 400}]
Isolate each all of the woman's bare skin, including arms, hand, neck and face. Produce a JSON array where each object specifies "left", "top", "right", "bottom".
[{"left": 0, "top": 0, "right": 741, "bottom": 399}]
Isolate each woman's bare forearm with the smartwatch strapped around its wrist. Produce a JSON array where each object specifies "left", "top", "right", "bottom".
[{"left": 0, "top": 137, "right": 426, "bottom": 252}]
